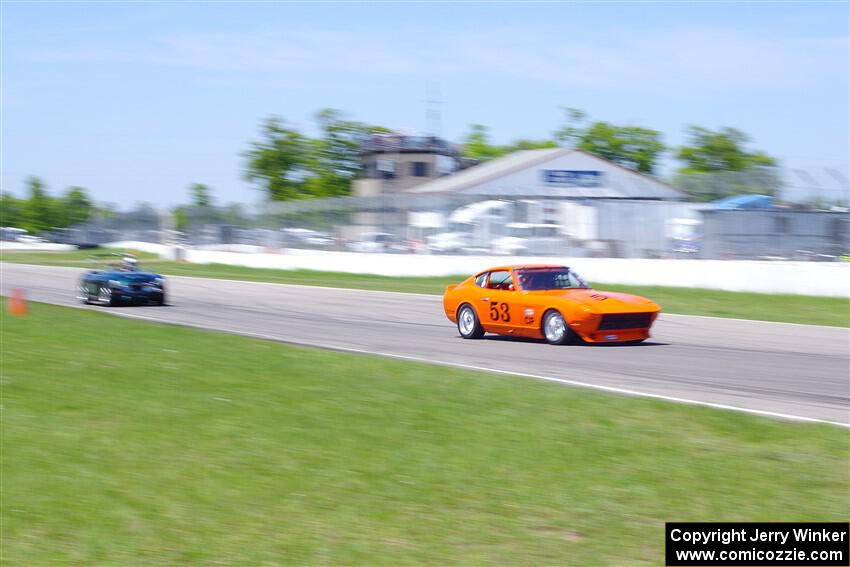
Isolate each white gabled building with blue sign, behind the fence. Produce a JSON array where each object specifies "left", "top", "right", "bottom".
[{"left": 405, "top": 148, "right": 701, "bottom": 257}]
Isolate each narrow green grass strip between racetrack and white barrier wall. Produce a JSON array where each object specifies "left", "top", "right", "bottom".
[{"left": 0, "top": 251, "right": 850, "bottom": 327}]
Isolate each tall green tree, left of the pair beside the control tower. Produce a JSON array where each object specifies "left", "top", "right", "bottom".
[{"left": 245, "top": 116, "right": 310, "bottom": 201}]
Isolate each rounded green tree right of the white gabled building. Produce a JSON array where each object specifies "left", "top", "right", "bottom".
[{"left": 676, "top": 126, "right": 776, "bottom": 173}]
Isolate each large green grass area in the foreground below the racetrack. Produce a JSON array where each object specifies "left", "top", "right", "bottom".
[{"left": 0, "top": 304, "right": 850, "bottom": 565}]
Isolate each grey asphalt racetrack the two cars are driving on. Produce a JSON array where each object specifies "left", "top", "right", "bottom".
[{"left": 6, "top": 263, "right": 850, "bottom": 425}]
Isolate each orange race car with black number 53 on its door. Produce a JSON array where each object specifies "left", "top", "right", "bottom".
[{"left": 443, "top": 266, "right": 661, "bottom": 345}]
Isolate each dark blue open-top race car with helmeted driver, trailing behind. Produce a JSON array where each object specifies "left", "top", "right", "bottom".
[{"left": 78, "top": 254, "right": 165, "bottom": 306}]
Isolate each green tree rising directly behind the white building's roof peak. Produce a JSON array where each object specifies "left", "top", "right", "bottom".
[{"left": 555, "top": 108, "right": 664, "bottom": 174}]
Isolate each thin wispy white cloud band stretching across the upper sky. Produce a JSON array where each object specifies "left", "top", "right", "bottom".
[{"left": 29, "top": 27, "right": 848, "bottom": 95}]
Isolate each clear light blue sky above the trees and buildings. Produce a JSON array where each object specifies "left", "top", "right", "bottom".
[{"left": 0, "top": 1, "right": 850, "bottom": 207}]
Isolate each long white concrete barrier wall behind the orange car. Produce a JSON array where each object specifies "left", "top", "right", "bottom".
[{"left": 171, "top": 249, "right": 850, "bottom": 297}]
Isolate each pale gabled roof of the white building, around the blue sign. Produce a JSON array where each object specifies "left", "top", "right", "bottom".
[{"left": 406, "top": 148, "right": 685, "bottom": 200}]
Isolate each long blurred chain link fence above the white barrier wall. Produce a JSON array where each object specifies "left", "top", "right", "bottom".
[{"left": 48, "top": 194, "right": 850, "bottom": 260}]
